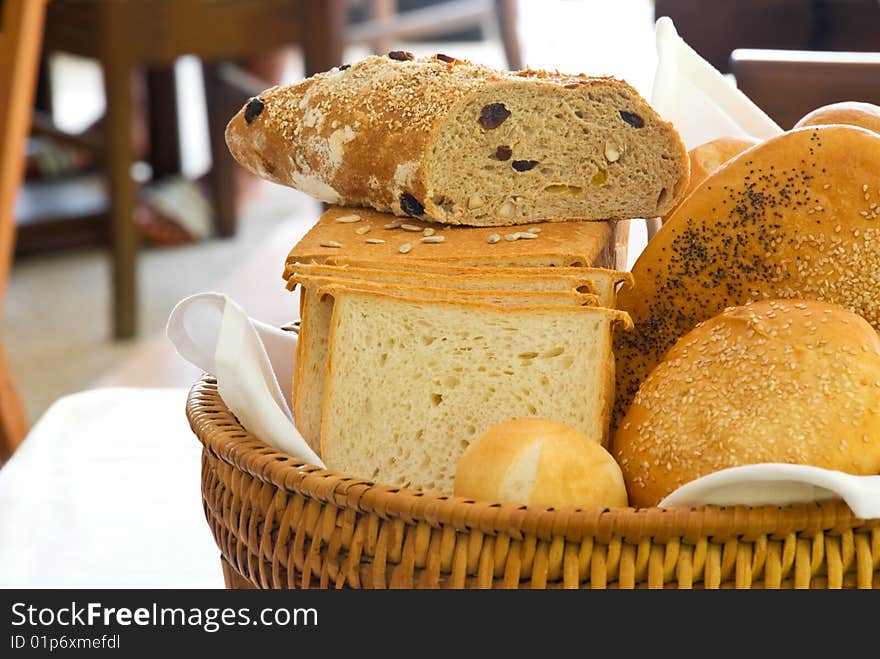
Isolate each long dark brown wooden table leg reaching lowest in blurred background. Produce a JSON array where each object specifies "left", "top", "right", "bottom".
[{"left": 104, "top": 56, "right": 137, "bottom": 339}]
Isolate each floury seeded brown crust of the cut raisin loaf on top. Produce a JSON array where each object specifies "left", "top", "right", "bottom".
[{"left": 226, "top": 52, "right": 688, "bottom": 226}]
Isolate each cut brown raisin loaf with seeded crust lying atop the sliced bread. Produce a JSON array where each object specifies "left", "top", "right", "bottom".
[{"left": 226, "top": 51, "right": 688, "bottom": 226}]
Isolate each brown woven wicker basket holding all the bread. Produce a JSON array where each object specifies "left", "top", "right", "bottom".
[{"left": 187, "top": 376, "right": 880, "bottom": 588}]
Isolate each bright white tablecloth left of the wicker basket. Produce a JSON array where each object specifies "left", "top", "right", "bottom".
[{"left": 0, "top": 389, "right": 223, "bottom": 588}]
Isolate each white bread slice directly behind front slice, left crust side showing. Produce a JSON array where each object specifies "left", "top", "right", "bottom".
[{"left": 291, "top": 274, "right": 599, "bottom": 451}]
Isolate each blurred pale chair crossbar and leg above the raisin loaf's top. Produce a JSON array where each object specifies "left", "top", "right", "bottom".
[{"left": 345, "top": 0, "right": 523, "bottom": 70}]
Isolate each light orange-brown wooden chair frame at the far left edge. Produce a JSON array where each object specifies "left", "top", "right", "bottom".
[{"left": 0, "top": 0, "right": 45, "bottom": 465}]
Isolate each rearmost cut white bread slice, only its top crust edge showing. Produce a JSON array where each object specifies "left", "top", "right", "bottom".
[{"left": 306, "top": 257, "right": 633, "bottom": 309}]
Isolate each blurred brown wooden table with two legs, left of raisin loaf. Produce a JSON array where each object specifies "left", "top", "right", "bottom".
[{"left": 38, "top": 0, "right": 345, "bottom": 338}]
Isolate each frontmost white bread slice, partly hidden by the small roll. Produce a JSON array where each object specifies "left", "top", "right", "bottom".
[{"left": 321, "top": 287, "right": 629, "bottom": 494}]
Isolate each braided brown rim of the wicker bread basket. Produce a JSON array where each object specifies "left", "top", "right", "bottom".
[{"left": 186, "top": 374, "right": 880, "bottom": 542}]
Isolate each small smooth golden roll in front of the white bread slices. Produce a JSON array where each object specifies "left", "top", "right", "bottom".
[{"left": 455, "top": 419, "right": 627, "bottom": 508}]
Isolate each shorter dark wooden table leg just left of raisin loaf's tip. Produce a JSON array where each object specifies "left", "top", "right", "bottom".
[{"left": 203, "top": 62, "right": 237, "bottom": 237}]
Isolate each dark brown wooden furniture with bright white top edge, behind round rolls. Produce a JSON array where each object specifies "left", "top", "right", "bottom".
[{"left": 730, "top": 49, "right": 880, "bottom": 129}]
